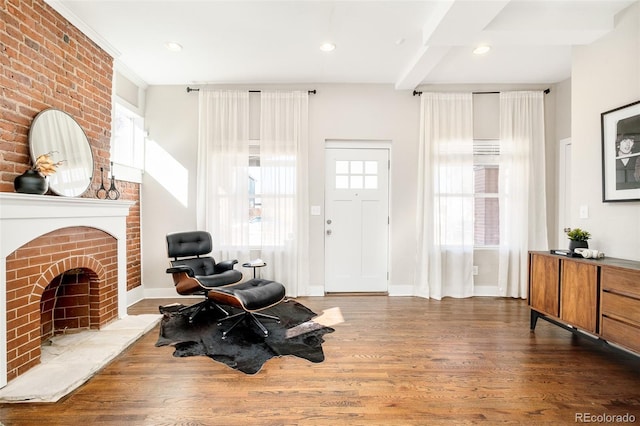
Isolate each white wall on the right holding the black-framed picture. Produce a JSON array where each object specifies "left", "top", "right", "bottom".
[{"left": 571, "top": 2, "right": 640, "bottom": 260}]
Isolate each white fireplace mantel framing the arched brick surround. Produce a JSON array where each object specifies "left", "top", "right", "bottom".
[{"left": 0, "top": 192, "right": 135, "bottom": 387}]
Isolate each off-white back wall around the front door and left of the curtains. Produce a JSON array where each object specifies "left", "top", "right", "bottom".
[{"left": 142, "top": 84, "right": 420, "bottom": 297}]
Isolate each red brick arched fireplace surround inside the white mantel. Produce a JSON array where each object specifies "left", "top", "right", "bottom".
[{"left": 6, "top": 227, "right": 118, "bottom": 380}]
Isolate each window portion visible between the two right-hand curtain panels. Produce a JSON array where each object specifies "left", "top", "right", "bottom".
[{"left": 473, "top": 140, "right": 500, "bottom": 247}]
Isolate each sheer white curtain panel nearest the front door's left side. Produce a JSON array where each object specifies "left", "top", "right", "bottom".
[{"left": 260, "top": 91, "right": 309, "bottom": 297}]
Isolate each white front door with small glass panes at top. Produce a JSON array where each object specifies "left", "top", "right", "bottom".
[{"left": 324, "top": 148, "right": 389, "bottom": 293}]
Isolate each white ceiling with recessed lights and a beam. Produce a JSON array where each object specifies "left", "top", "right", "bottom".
[{"left": 45, "top": 0, "right": 638, "bottom": 90}]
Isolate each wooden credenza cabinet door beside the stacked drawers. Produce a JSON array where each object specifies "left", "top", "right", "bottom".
[{"left": 560, "top": 260, "right": 598, "bottom": 333}]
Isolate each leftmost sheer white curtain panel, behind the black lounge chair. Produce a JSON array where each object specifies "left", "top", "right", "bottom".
[{"left": 196, "top": 89, "right": 249, "bottom": 262}]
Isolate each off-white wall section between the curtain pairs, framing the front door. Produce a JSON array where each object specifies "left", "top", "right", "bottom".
[{"left": 309, "top": 84, "right": 420, "bottom": 294}]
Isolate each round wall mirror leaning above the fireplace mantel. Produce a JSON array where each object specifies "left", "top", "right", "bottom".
[{"left": 29, "top": 109, "right": 93, "bottom": 197}]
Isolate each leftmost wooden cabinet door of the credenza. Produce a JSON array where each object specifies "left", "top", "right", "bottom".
[{"left": 529, "top": 254, "right": 560, "bottom": 317}]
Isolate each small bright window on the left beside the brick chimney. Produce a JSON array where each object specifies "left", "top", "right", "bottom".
[{"left": 111, "top": 103, "right": 144, "bottom": 170}]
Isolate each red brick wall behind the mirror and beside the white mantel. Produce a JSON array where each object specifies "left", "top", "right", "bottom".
[{"left": 0, "top": 0, "right": 141, "bottom": 290}]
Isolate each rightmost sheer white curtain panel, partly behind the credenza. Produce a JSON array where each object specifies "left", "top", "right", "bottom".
[{"left": 498, "top": 92, "right": 548, "bottom": 298}]
